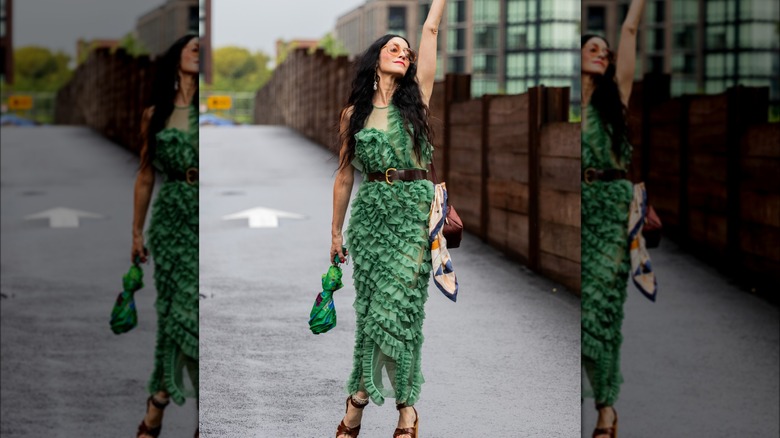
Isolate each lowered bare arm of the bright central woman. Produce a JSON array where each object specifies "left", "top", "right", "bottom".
[{"left": 330, "top": 107, "right": 355, "bottom": 263}]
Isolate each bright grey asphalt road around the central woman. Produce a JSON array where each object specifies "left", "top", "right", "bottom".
[{"left": 200, "top": 127, "right": 581, "bottom": 438}]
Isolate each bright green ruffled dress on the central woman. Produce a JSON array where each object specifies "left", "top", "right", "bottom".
[{"left": 346, "top": 105, "right": 433, "bottom": 405}]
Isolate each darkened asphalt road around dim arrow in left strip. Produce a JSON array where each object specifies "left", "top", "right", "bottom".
[{"left": 0, "top": 127, "right": 197, "bottom": 438}]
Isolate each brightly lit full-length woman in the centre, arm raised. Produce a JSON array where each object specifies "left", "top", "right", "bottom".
[{"left": 330, "top": 0, "right": 445, "bottom": 438}]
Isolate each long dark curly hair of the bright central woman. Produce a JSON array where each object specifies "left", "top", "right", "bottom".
[{"left": 339, "top": 35, "right": 433, "bottom": 169}]
